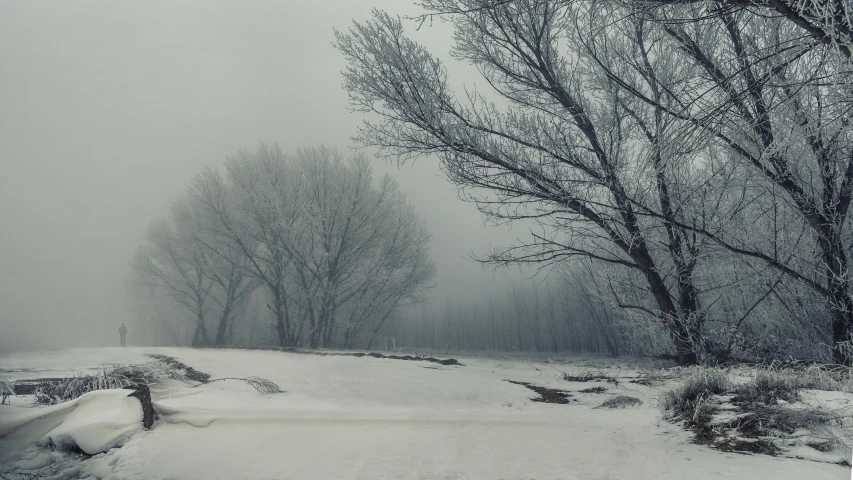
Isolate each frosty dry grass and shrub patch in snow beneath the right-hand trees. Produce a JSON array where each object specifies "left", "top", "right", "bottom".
[{"left": 661, "top": 367, "right": 853, "bottom": 463}]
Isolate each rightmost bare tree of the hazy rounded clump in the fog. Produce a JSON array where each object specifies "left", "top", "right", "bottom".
[{"left": 287, "top": 147, "right": 435, "bottom": 348}]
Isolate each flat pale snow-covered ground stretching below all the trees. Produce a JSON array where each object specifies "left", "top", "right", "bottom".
[{"left": 0, "top": 348, "right": 851, "bottom": 480}]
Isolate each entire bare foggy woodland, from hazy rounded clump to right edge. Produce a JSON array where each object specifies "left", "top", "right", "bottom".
[{"left": 132, "top": 0, "right": 853, "bottom": 365}]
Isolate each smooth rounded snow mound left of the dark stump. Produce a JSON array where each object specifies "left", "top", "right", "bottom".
[{"left": 44, "top": 389, "right": 142, "bottom": 455}]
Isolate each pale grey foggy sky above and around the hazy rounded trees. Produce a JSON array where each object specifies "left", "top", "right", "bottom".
[{"left": 0, "top": 0, "right": 525, "bottom": 351}]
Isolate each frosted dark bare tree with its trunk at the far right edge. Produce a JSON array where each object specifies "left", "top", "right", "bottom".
[{"left": 585, "top": 2, "right": 853, "bottom": 362}]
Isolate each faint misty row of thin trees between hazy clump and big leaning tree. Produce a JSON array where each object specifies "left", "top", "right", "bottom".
[{"left": 379, "top": 275, "right": 624, "bottom": 356}]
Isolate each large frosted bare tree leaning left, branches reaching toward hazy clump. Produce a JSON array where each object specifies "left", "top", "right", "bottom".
[{"left": 337, "top": 0, "right": 724, "bottom": 364}]
